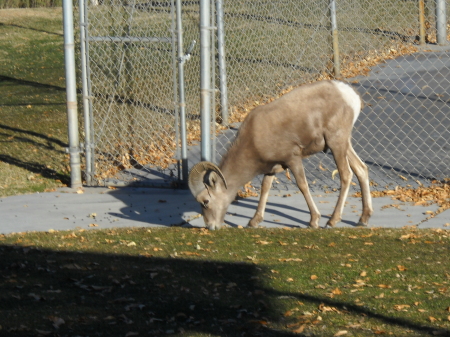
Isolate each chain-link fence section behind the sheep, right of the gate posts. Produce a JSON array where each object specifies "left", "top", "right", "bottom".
[{"left": 206, "top": 0, "right": 450, "bottom": 189}]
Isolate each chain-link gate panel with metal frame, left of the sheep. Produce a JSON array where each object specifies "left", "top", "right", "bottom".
[{"left": 79, "top": 0, "right": 188, "bottom": 186}]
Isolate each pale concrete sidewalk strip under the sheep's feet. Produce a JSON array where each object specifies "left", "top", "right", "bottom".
[{"left": 0, "top": 187, "right": 450, "bottom": 234}]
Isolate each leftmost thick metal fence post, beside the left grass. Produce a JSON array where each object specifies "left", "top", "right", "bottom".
[{"left": 63, "top": 0, "right": 82, "bottom": 188}]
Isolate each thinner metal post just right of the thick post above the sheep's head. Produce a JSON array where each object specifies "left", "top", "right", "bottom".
[{"left": 216, "top": 0, "right": 228, "bottom": 125}]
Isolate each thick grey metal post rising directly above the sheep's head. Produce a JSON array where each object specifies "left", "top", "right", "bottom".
[{"left": 200, "top": 0, "right": 211, "bottom": 161}]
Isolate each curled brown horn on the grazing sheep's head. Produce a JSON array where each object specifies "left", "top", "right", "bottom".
[{"left": 188, "top": 161, "right": 227, "bottom": 198}]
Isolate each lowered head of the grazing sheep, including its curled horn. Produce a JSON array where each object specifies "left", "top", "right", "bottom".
[{"left": 189, "top": 161, "right": 229, "bottom": 230}]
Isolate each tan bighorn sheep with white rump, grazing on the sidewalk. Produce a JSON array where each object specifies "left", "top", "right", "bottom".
[{"left": 189, "top": 81, "right": 373, "bottom": 229}]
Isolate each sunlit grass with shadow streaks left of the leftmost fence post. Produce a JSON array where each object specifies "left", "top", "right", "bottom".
[{"left": 0, "top": 8, "right": 69, "bottom": 197}]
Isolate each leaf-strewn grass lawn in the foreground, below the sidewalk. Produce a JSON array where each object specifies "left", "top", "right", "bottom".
[{"left": 0, "top": 224, "right": 450, "bottom": 336}]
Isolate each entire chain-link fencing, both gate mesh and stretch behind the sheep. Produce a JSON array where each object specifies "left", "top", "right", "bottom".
[{"left": 78, "top": 0, "right": 450, "bottom": 188}]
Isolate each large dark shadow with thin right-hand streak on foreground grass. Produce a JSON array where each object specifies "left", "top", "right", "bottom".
[{"left": 0, "top": 244, "right": 450, "bottom": 336}]
